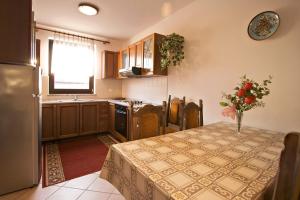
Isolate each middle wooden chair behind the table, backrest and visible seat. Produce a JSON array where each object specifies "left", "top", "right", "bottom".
[{"left": 166, "top": 95, "right": 185, "bottom": 133}]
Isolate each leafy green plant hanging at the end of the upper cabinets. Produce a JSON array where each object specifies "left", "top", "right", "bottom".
[{"left": 159, "top": 33, "right": 184, "bottom": 69}]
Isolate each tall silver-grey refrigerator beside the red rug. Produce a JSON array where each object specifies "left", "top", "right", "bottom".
[{"left": 0, "top": 64, "right": 42, "bottom": 195}]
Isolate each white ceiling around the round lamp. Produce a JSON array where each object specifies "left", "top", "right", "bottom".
[{"left": 33, "top": 0, "right": 194, "bottom": 39}]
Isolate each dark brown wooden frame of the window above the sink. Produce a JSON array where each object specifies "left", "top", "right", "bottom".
[{"left": 48, "top": 39, "right": 94, "bottom": 94}]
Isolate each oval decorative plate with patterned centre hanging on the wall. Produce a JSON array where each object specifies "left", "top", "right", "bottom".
[{"left": 248, "top": 11, "right": 280, "bottom": 40}]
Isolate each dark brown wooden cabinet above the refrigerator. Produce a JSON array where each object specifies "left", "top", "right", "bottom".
[{"left": 0, "top": 0, "right": 35, "bottom": 65}]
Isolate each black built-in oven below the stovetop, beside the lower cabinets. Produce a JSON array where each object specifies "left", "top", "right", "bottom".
[{"left": 115, "top": 104, "right": 128, "bottom": 139}]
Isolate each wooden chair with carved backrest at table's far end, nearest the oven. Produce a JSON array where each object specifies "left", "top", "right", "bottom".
[{"left": 130, "top": 101, "right": 166, "bottom": 140}]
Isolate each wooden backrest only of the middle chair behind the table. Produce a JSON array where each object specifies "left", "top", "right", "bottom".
[{"left": 166, "top": 95, "right": 185, "bottom": 126}]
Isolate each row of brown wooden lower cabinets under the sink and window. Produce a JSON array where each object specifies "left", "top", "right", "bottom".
[{"left": 42, "top": 102, "right": 109, "bottom": 141}]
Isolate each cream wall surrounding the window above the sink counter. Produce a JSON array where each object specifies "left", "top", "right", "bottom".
[{"left": 37, "top": 30, "right": 122, "bottom": 100}]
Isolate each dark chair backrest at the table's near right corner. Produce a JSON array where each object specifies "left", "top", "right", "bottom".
[{"left": 272, "top": 133, "right": 300, "bottom": 200}]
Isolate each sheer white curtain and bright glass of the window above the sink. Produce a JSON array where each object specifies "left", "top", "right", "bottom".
[{"left": 51, "top": 34, "right": 96, "bottom": 89}]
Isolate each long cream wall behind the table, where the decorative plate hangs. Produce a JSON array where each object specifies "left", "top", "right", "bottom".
[{"left": 122, "top": 0, "right": 300, "bottom": 131}]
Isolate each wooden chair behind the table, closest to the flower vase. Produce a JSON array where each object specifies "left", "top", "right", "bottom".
[{"left": 180, "top": 99, "right": 203, "bottom": 130}]
